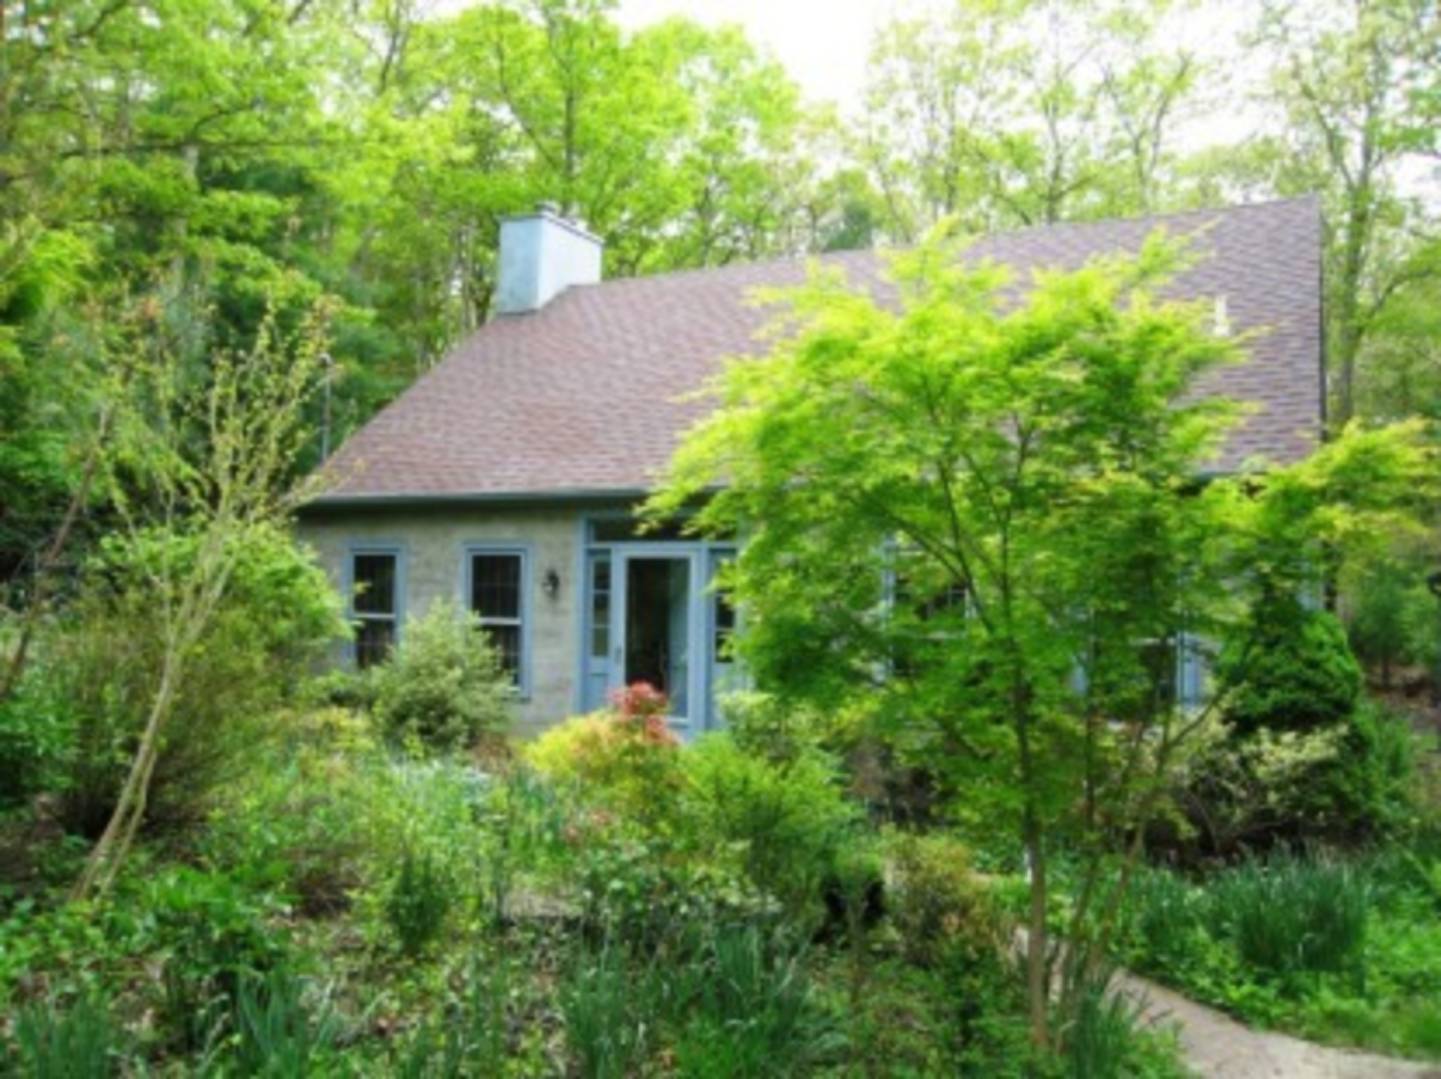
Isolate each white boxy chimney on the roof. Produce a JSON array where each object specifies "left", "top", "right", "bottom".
[{"left": 496, "top": 203, "right": 601, "bottom": 314}]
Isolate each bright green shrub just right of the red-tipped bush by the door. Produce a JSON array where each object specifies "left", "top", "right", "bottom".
[{"left": 680, "top": 733, "right": 857, "bottom": 906}]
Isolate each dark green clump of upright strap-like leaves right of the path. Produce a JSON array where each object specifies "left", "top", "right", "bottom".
[{"left": 1209, "top": 854, "right": 1372, "bottom": 978}]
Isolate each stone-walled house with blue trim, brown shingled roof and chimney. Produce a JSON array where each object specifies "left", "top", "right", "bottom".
[{"left": 300, "top": 199, "right": 1323, "bottom": 733}]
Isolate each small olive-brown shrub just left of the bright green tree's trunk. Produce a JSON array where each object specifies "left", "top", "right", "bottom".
[{"left": 891, "top": 834, "right": 1009, "bottom": 965}]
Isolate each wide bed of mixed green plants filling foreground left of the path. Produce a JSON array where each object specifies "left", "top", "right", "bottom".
[{"left": 0, "top": 605, "right": 1176, "bottom": 1076}]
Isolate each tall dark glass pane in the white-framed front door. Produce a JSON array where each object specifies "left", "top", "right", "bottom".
[{"left": 625, "top": 558, "right": 690, "bottom": 717}]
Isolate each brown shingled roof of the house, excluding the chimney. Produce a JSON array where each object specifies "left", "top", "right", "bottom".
[{"left": 316, "top": 199, "right": 1323, "bottom": 504}]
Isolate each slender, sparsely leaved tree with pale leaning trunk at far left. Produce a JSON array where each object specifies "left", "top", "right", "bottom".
[{"left": 73, "top": 298, "right": 323, "bottom": 896}]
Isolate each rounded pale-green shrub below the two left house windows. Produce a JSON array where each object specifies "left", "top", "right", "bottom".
[{"left": 370, "top": 601, "right": 514, "bottom": 752}]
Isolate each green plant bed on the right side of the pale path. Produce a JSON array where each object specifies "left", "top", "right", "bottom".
[{"left": 1120, "top": 846, "right": 1441, "bottom": 1060}]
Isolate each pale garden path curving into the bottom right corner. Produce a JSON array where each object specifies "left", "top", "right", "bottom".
[{"left": 1115, "top": 974, "right": 1441, "bottom": 1079}]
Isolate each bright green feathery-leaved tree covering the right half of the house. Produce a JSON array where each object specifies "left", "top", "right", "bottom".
[{"left": 650, "top": 224, "right": 1434, "bottom": 1044}]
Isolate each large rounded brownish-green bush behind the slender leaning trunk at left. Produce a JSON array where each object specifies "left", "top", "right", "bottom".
[{"left": 27, "top": 527, "right": 346, "bottom": 836}]
